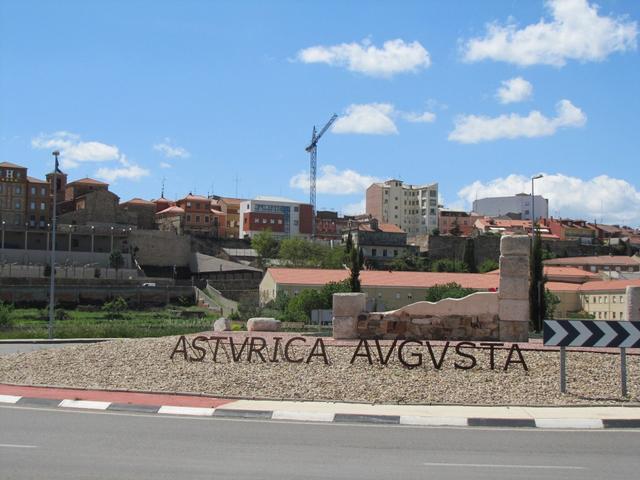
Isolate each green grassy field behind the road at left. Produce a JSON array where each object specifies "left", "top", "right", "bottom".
[{"left": 0, "top": 306, "right": 218, "bottom": 339}]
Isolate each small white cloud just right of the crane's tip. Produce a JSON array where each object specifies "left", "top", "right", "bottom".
[{"left": 331, "top": 103, "right": 398, "bottom": 135}]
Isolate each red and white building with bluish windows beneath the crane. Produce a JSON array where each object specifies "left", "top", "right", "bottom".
[{"left": 240, "top": 197, "right": 313, "bottom": 238}]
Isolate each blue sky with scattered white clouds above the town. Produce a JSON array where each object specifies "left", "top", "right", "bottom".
[{"left": 0, "top": 0, "right": 640, "bottom": 226}]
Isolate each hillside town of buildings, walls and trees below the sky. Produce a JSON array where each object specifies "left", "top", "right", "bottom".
[{"left": 0, "top": 162, "right": 640, "bottom": 321}]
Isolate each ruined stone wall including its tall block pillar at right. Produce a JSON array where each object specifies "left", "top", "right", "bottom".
[{"left": 333, "top": 235, "right": 530, "bottom": 342}]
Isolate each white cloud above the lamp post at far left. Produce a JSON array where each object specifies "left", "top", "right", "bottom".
[{"left": 31, "top": 131, "right": 120, "bottom": 169}]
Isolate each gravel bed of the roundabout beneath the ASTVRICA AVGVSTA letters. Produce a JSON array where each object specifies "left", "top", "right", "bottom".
[{"left": 0, "top": 336, "right": 640, "bottom": 405}]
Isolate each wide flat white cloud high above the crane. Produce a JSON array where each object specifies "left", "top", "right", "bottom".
[{"left": 298, "top": 39, "right": 431, "bottom": 77}]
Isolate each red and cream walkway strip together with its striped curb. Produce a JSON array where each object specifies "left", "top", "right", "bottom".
[{"left": 0, "top": 384, "right": 640, "bottom": 430}]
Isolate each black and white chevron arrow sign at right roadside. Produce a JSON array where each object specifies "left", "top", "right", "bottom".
[{"left": 544, "top": 320, "right": 640, "bottom": 348}]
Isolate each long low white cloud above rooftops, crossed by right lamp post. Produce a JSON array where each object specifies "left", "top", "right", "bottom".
[{"left": 458, "top": 174, "right": 640, "bottom": 225}]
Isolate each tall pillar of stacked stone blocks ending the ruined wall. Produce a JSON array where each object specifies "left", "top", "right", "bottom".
[{"left": 498, "top": 235, "right": 531, "bottom": 342}]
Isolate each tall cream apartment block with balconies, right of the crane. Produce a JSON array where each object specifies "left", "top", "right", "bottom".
[{"left": 366, "top": 179, "right": 438, "bottom": 236}]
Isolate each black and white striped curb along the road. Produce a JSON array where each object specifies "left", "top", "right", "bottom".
[{"left": 0, "top": 395, "right": 640, "bottom": 430}]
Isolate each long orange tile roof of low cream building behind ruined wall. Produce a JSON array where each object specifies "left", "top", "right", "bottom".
[{"left": 267, "top": 268, "right": 499, "bottom": 290}]
